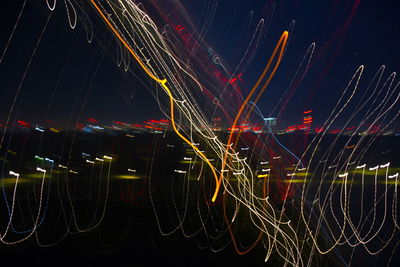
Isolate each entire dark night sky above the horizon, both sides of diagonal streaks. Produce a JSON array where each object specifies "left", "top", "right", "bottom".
[{"left": 0, "top": 0, "right": 400, "bottom": 130}]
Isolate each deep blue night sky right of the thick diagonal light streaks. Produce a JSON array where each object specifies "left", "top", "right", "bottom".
[{"left": 186, "top": 0, "right": 400, "bottom": 125}]
